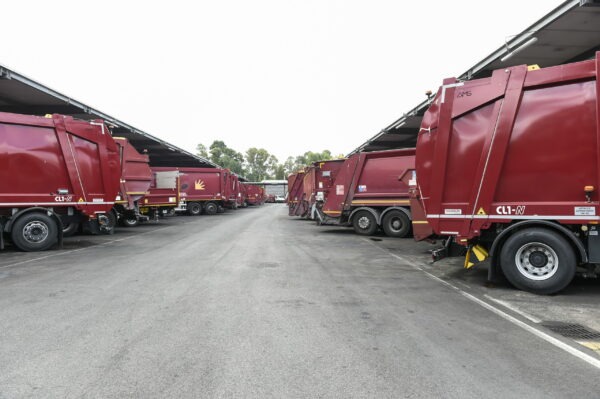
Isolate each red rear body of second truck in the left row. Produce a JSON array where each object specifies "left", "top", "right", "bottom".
[{"left": 114, "top": 137, "right": 152, "bottom": 209}]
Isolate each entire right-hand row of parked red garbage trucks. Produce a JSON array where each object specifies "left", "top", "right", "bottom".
[{"left": 288, "top": 52, "right": 600, "bottom": 294}]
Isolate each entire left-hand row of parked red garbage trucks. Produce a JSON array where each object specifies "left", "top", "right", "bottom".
[{"left": 0, "top": 113, "right": 265, "bottom": 251}]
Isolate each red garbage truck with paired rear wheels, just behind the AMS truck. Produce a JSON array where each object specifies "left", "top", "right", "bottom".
[{"left": 316, "top": 148, "right": 415, "bottom": 237}]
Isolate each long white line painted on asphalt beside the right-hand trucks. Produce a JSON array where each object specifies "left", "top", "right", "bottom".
[{"left": 364, "top": 239, "right": 600, "bottom": 369}]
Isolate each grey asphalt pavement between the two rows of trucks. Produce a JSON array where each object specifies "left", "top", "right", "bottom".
[{"left": 0, "top": 204, "right": 600, "bottom": 399}]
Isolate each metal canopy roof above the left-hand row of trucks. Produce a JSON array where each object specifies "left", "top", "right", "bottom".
[{"left": 0, "top": 65, "right": 218, "bottom": 167}]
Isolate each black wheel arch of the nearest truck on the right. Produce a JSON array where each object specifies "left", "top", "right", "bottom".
[{"left": 488, "top": 220, "right": 588, "bottom": 281}]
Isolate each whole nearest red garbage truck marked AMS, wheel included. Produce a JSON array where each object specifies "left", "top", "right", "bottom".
[{"left": 413, "top": 53, "right": 600, "bottom": 294}]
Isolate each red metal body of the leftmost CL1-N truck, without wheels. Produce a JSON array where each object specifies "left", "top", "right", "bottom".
[{"left": 0, "top": 113, "right": 121, "bottom": 219}]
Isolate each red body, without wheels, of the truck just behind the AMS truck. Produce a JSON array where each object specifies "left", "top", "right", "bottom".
[{"left": 322, "top": 149, "right": 415, "bottom": 218}]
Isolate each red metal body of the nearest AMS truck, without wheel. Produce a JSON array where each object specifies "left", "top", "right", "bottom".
[{"left": 413, "top": 53, "right": 600, "bottom": 244}]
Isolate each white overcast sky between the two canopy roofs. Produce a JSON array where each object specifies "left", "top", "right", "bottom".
[{"left": 0, "top": 0, "right": 562, "bottom": 162}]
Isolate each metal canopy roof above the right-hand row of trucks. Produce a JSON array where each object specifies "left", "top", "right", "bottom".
[{"left": 349, "top": 0, "right": 600, "bottom": 155}]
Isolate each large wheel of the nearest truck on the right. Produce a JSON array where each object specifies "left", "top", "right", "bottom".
[{"left": 500, "top": 228, "right": 577, "bottom": 294}]
